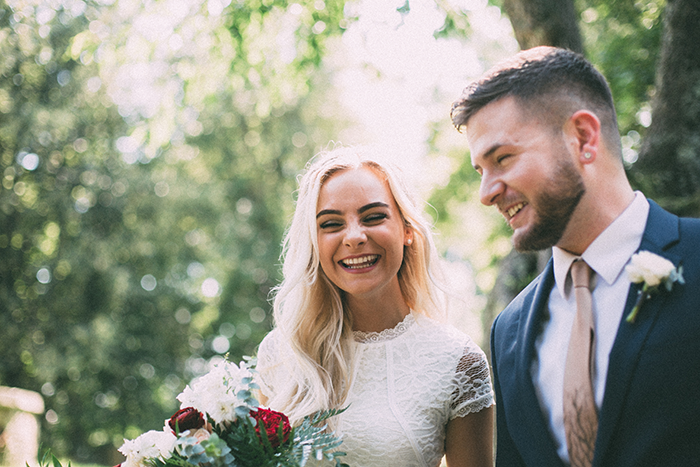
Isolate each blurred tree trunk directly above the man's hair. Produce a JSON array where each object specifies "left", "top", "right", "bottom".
[{"left": 503, "top": 0, "right": 583, "bottom": 53}]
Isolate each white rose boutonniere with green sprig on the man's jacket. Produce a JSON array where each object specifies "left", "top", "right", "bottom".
[{"left": 625, "top": 251, "right": 685, "bottom": 323}]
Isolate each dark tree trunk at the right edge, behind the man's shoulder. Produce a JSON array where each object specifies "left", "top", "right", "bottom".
[{"left": 630, "top": 0, "right": 700, "bottom": 216}]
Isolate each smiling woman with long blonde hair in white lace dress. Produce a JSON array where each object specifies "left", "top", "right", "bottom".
[{"left": 257, "top": 147, "right": 494, "bottom": 467}]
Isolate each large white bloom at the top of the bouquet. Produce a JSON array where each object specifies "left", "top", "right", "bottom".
[{"left": 177, "top": 361, "right": 253, "bottom": 423}]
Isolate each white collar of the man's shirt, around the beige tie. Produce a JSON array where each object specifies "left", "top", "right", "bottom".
[{"left": 552, "top": 191, "right": 649, "bottom": 298}]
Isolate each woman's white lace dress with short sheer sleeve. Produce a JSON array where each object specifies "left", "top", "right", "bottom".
[{"left": 258, "top": 314, "right": 494, "bottom": 467}]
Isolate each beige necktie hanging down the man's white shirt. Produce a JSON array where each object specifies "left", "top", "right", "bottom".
[{"left": 564, "top": 260, "right": 598, "bottom": 467}]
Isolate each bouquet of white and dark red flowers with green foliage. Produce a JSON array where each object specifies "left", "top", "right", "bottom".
[{"left": 114, "top": 360, "right": 348, "bottom": 467}]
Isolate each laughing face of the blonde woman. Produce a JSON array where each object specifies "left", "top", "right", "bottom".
[{"left": 316, "top": 167, "right": 412, "bottom": 304}]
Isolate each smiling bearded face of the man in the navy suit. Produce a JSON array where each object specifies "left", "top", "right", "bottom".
[{"left": 467, "top": 97, "right": 585, "bottom": 251}]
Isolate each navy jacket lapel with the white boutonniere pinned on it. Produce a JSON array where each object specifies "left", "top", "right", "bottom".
[{"left": 593, "top": 200, "right": 680, "bottom": 465}]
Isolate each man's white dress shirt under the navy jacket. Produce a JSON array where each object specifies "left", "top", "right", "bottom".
[{"left": 531, "top": 192, "right": 649, "bottom": 463}]
